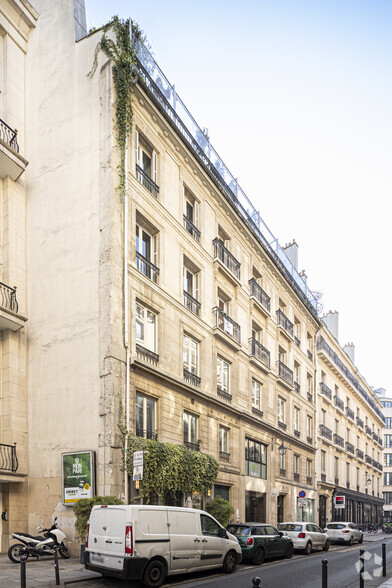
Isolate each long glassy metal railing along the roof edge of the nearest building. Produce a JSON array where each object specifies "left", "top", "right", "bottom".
[{"left": 134, "top": 40, "right": 317, "bottom": 314}]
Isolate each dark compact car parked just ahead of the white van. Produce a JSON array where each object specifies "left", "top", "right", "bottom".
[{"left": 226, "top": 523, "right": 294, "bottom": 565}]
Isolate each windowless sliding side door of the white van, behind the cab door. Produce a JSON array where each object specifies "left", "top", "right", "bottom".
[{"left": 167, "top": 508, "right": 202, "bottom": 570}]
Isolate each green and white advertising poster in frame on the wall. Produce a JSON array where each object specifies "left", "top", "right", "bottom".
[{"left": 62, "top": 451, "right": 95, "bottom": 505}]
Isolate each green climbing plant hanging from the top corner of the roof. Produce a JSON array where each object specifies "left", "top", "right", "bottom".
[{"left": 87, "top": 16, "right": 145, "bottom": 198}]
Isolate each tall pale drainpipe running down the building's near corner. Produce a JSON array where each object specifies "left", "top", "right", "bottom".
[{"left": 124, "top": 137, "right": 130, "bottom": 504}]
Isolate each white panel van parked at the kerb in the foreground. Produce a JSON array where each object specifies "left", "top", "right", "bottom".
[{"left": 85, "top": 505, "right": 242, "bottom": 586}]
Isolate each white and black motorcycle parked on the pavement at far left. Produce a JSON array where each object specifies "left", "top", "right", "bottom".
[{"left": 8, "top": 517, "right": 71, "bottom": 563}]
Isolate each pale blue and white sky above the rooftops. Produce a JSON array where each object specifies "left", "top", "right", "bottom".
[{"left": 85, "top": 0, "right": 392, "bottom": 396}]
